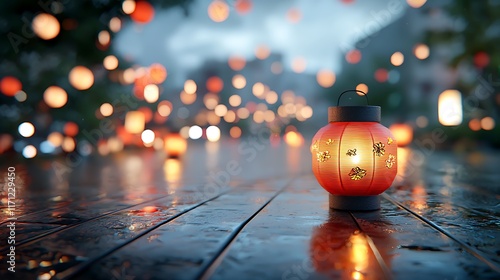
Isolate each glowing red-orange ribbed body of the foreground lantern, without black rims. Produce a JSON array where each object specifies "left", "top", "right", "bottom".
[{"left": 311, "top": 122, "right": 397, "bottom": 196}]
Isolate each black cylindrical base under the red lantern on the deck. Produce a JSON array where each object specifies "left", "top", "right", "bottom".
[{"left": 330, "top": 194, "right": 380, "bottom": 211}]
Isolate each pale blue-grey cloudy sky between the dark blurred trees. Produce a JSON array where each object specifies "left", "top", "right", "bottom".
[{"left": 114, "top": 0, "right": 406, "bottom": 84}]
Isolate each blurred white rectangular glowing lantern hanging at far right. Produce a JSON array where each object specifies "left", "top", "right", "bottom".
[{"left": 438, "top": 89, "right": 463, "bottom": 126}]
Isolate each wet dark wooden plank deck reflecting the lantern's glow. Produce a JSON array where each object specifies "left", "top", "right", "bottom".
[{"left": 0, "top": 142, "right": 500, "bottom": 280}]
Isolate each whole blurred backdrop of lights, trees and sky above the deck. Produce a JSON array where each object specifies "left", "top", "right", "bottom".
[{"left": 0, "top": 0, "right": 500, "bottom": 159}]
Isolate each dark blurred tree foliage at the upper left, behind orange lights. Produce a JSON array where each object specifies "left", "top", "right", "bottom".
[{"left": 0, "top": 0, "right": 192, "bottom": 136}]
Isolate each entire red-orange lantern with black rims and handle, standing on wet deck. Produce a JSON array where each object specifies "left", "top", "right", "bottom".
[{"left": 311, "top": 90, "right": 397, "bottom": 210}]
